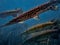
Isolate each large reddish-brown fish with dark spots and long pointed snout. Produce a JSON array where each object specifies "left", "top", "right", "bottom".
[{"left": 0, "top": 0, "right": 60, "bottom": 26}]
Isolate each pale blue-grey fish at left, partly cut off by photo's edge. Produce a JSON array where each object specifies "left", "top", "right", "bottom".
[{"left": 0, "top": 9, "right": 23, "bottom": 18}]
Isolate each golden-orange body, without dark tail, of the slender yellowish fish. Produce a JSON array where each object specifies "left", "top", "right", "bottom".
[{"left": 23, "top": 22, "right": 55, "bottom": 33}]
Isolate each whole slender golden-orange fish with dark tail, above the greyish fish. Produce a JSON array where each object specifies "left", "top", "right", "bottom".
[{"left": 23, "top": 19, "right": 60, "bottom": 33}]
